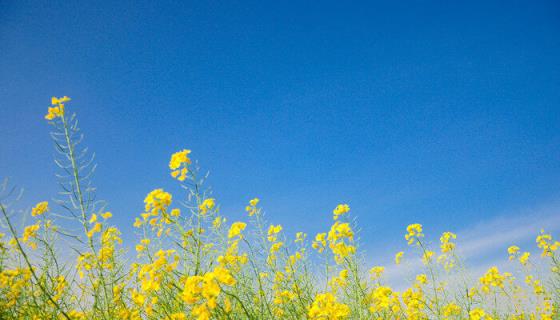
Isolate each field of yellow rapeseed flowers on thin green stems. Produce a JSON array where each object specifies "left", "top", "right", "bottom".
[{"left": 0, "top": 96, "right": 560, "bottom": 320}]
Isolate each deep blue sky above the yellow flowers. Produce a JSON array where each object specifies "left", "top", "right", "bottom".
[{"left": 0, "top": 1, "right": 560, "bottom": 262}]
